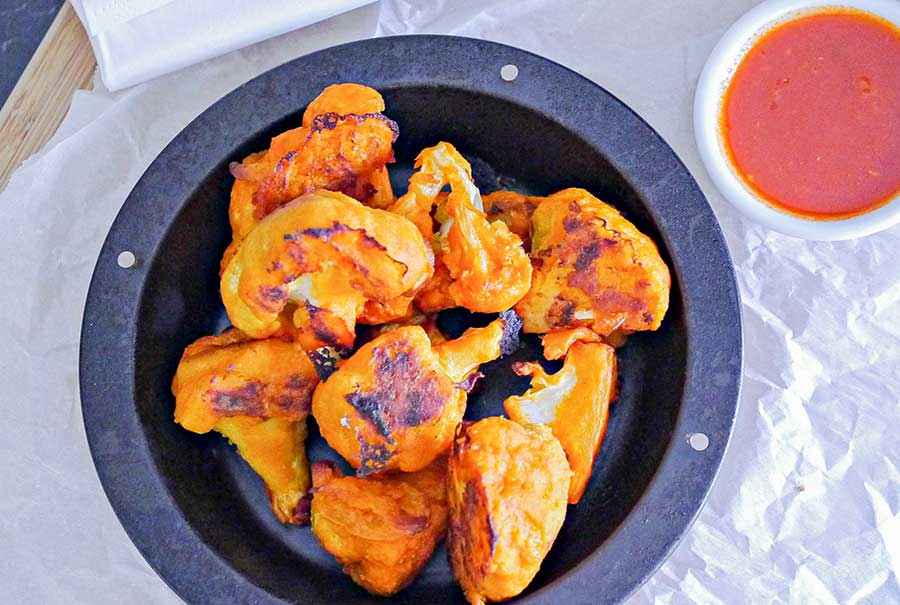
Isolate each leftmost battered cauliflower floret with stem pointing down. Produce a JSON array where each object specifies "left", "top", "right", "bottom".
[{"left": 172, "top": 329, "right": 319, "bottom": 524}]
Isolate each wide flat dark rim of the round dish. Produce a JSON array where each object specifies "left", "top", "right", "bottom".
[{"left": 79, "top": 35, "right": 743, "bottom": 604}]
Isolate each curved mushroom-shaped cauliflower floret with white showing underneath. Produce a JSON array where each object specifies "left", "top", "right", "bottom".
[{"left": 221, "top": 190, "right": 432, "bottom": 350}]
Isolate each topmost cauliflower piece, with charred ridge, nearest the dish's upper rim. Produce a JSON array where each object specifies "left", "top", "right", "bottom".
[{"left": 223, "top": 83, "right": 397, "bottom": 243}]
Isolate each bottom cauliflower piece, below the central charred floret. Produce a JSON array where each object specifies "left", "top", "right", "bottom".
[{"left": 312, "top": 457, "right": 447, "bottom": 596}]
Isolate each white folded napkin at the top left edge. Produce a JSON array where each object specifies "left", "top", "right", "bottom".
[{"left": 71, "top": 0, "right": 375, "bottom": 90}]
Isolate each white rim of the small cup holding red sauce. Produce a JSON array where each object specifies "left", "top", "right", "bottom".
[{"left": 694, "top": 0, "right": 900, "bottom": 241}]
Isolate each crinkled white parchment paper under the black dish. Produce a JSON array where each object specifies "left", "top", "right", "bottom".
[{"left": 0, "top": 0, "right": 900, "bottom": 605}]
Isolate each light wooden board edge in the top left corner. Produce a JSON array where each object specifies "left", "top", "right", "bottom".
[{"left": 0, "top": 2, "right": 97, "bottom": 191}]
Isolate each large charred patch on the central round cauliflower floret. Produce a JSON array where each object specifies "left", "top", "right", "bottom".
[{"left": 344, "top": 343, "right": 446, "bottom": 445}]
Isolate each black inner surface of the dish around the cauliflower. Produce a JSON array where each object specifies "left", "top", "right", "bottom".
[{"left": 134, "top": 86, "right": 687, "bottom": 604}]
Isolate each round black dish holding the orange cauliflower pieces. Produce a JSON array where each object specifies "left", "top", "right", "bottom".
[{"left": 81, "top": 36, "right": 741, "bottom": 605}]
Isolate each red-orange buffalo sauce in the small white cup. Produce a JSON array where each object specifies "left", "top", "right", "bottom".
[{"left": 720, "top": 9, "right": 900, "bottom": 219}]
